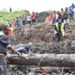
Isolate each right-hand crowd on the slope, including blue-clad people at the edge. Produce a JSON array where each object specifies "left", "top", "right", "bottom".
[{"left": 48, "top": 4, "right": 75, "bottom": 42}]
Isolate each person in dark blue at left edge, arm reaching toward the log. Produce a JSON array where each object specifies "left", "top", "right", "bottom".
[{"left": 0, "top": 26, "right": 21, "bottom": 75}]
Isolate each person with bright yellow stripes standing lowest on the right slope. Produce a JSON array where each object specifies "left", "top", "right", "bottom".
[{"left": 55, "top": 15, "right": 64, "bottom": 42}]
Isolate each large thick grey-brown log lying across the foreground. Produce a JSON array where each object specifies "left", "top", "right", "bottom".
[{"left": 7, "top": 54, "right": 75, "bottom": 67}]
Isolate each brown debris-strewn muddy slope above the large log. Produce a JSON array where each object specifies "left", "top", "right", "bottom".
[{"left": 15, "top": 23, "right": 75, "bottom": 54}]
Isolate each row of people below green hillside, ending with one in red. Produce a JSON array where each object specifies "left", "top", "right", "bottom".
[{"left": 12, "top": 12, "right": 37, "bottom": 28}]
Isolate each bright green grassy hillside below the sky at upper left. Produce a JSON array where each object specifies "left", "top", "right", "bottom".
[{"left": 0, "top": 10, "right": 29, "bottom": 25}]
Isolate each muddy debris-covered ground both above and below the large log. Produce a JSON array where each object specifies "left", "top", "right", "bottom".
[{"left": 0, "top": 24, "right": 75, "bottom": 75}]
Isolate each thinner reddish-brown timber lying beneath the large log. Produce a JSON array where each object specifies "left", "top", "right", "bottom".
[{"left": 30, "top": 67, "right": 75, "bottom": 73}]
